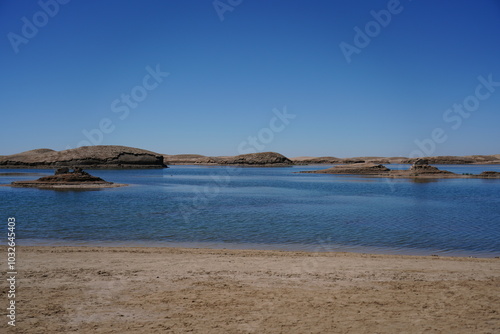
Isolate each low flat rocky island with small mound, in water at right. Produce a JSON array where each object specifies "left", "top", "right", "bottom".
[{"left": 300, "top": 159, "right": 500, "bottom": 179}]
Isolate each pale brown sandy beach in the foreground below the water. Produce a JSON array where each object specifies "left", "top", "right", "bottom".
[{"left": 0, "top": 247, "right": 500, "bottom": 334}]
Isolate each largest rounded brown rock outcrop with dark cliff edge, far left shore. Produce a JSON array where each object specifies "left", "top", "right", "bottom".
[{"left": 0, "top": 145, "right": 166, "bottom": 169}]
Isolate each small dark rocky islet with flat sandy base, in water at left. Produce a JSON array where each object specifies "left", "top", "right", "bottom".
[{"left": 10, "top": 167, "right": 126, "bottom": 189}]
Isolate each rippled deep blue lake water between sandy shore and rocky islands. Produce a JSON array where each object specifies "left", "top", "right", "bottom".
[{"left": 0, "top": 165, "right": 500, "bottom": 257}]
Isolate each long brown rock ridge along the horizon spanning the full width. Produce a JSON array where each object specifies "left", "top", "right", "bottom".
[{"left": 4, "top": 145, "right": 500, "bottom": 169}]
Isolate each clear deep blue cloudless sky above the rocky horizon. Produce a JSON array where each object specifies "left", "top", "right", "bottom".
[{"left": 0, "top": 0, "right": 500, "bottom": 157}]
